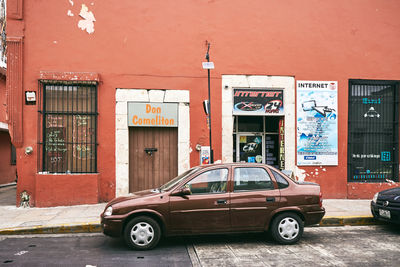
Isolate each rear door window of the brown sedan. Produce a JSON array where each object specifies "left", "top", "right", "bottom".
[{"left": 233, "top": 168, "right": 274, "bottom": 191}]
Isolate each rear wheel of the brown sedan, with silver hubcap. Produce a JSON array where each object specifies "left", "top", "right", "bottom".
[{"left": 271, "top": 212, "right": 304, "bottom": 245}]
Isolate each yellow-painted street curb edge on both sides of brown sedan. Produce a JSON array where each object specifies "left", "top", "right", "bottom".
[{"left": 0, "top": 216, "right": 383, "bottom": 235}]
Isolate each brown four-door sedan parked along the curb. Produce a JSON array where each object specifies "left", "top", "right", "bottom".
[{"left": 101, "top": 163, "right": 325, "bottom": 249}]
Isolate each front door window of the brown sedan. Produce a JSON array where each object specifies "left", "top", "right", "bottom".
[{"left": 185, "top": 169, "right": 228, "bottom": 194}]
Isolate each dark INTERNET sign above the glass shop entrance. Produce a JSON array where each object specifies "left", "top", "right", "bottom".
[{"left": 233, "top": 88, "right": 284, "bottom": 115}]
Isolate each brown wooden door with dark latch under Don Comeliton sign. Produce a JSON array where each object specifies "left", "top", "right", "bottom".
[{"left": 129, "top": 127, "right": 178, "bottom": 192}]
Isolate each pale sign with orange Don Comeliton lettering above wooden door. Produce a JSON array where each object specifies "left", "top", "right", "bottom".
[{"left": 128, "top": 102, "right": 178, "bottom": 127}]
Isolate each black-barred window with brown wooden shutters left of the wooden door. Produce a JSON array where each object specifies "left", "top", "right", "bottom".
[{"left": 39, "top": 81, "right": 98, "bottom": 173}]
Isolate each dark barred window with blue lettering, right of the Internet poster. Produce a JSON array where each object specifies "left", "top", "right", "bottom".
[{"left": 347, "top": 80, "right": 399, "bottom": 182}]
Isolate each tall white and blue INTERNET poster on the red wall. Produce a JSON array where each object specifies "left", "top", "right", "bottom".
[{"left": 297, "top": 81, "right": 338, "bottom": 166}]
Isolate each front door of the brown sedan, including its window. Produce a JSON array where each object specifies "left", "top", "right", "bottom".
[{"left": 170, "top": 168, "right": 230, "bottom": 236}]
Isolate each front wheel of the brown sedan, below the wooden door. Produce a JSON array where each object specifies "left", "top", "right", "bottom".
[{"left": 124, "top": 216, "right": 161, "bottom": 250}]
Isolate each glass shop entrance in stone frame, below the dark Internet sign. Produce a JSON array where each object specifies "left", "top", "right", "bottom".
[{"left": 233, "top": 116, "right": 285, "bottom": 169}]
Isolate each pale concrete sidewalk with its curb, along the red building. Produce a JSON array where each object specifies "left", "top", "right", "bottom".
[{"left": 0, "top": 185, "right": 379, "bottom": 235}]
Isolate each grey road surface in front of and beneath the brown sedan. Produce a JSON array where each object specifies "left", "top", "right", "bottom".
[{"left": 0, "top": 225, "right": 400, "bottom": 267}]
